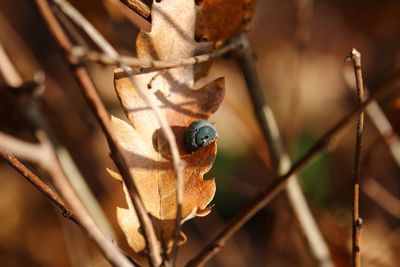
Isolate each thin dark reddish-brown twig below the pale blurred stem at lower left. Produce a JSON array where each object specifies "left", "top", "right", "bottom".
[{"left": 0, "top": 152, "right": 75, "bottom": 221}]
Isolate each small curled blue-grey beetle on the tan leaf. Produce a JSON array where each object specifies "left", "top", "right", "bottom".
[{"left": 184, "top": 120, "right": 218, "bottom": 152}]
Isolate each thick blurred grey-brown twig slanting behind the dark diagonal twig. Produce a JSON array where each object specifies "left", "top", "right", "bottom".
[{"left": 233, "top": 35, "right": 333, "bottom": 267}]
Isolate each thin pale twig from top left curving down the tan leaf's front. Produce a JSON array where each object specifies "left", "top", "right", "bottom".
[{"left": 48, "top": 0, "right": 189, "bottom": 264}]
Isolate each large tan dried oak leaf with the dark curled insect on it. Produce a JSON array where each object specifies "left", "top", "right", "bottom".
[{"left": 111, "top": 0, "right": 224, "bottom": 251}]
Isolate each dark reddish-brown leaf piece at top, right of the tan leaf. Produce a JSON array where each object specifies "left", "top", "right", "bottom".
[{"left": 195, "top": 0, "right": 256, "bottom": 47}]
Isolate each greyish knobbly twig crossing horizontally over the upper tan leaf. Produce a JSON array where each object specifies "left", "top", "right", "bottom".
[{"left": 71, "top": 42, "right": 241, "bottom": 73}]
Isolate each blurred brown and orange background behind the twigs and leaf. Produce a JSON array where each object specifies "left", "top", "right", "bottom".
[{"left": 0, "top": 0, "right": 400, "bottom": 267}]
